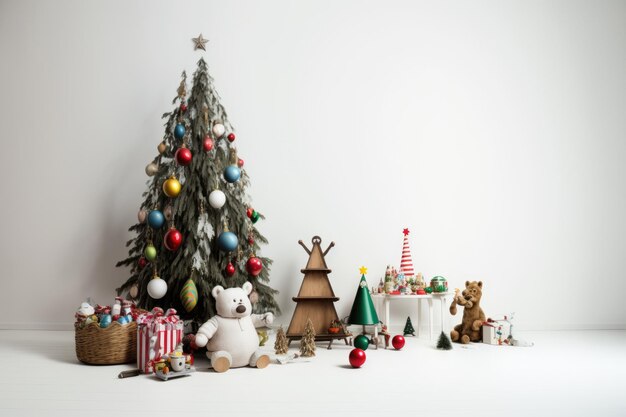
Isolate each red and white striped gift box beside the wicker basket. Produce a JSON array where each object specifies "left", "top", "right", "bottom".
[{"left": 137, "top": 307, "right": 183, "bottom": 373}]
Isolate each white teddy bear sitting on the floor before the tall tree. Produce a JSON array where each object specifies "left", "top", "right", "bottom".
[{"left": 195, "top": 282, "right": 274, "bottom": 372}]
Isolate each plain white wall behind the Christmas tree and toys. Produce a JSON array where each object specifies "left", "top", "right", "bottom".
[{"left": 0, "top": 0, "right": 626, "bottom": 329}]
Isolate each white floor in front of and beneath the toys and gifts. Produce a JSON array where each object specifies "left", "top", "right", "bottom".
[{"left": 0, "top": 331, "right": 626, "bottom": 417}]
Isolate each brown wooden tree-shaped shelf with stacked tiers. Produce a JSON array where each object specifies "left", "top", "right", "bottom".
[{"left": 287, "top": 236, "right": 351, "bottom": 349}]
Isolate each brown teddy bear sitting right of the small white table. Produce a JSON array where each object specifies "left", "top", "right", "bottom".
[{"left": 450, "top": 281, "right": 486, "bottom": 343}]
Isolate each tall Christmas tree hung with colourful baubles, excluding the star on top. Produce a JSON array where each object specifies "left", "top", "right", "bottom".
[{"left": 117, "top": 59, "right": 280, "bottom": 322}]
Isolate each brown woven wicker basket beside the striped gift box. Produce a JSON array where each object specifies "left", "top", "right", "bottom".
[{"left": 74, "top": 321, "right": 137, "bottom": 365}]
